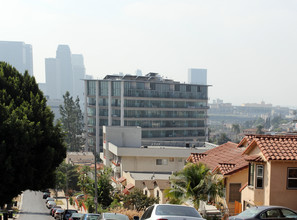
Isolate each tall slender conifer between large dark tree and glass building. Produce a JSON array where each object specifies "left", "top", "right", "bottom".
[{"left": 60, "top": 91, "right": 84, "bottom": 151}]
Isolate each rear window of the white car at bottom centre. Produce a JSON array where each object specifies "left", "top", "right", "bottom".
[{"left": 156, "top": 205, "right": 201, "bottom": 218}]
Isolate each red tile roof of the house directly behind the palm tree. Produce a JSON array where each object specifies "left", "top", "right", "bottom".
[{"left": 188, "top": 142, "right": 248, "bottom": 175}]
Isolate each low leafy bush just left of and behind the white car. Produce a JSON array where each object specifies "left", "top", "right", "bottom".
[{"left": 123, "top": 189, "right": 159, "bottom": 211}]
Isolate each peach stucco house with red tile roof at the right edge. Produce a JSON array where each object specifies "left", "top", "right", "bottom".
[{"left": 238, "top": 135, "right": 297, "bottom": 210}]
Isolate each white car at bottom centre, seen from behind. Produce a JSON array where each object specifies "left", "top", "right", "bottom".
[{"left": 141, "top": 204, "right": 204, "bottom": 220}]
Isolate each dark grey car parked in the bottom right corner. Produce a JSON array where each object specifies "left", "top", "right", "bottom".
[{"left": 229, "top": 206, "right": 297, "bottom": 220}]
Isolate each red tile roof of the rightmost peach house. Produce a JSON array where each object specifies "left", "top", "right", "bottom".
[{"left": 243, "top": 135, "right": 297, "bottom": 160}]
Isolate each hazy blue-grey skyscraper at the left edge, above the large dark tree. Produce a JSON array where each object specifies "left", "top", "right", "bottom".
[{"left": 0, "top": 41, "right": 33, "bottom": 76}]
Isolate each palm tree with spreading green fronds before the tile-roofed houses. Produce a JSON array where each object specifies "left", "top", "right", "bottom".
[{"left": 165, "top": 163, "right": 223, "bottom": 209}]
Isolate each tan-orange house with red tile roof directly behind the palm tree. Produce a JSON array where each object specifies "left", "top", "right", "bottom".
[{"left": 188, "top": 142, "right": 248, "bottom": 215}]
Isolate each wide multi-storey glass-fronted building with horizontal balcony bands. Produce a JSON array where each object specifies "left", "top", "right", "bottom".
[{"left": 84, "top": 73, "right": 208, "bottom": 150}]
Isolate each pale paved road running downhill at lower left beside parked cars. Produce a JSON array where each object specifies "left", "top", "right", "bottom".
[{"left": 18, "top": 190, "right": 54, "bottom": 220}]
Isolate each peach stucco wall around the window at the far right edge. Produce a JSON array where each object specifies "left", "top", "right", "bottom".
[{"left": 269, "top": 161, "right": 297, "bottom": 210}]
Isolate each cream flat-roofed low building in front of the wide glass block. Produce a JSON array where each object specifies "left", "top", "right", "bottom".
[{"left": 100, "top": 126, "right": 213, "bottom": 202}]
